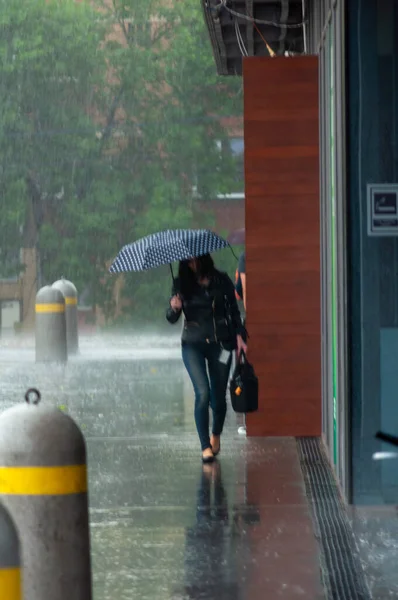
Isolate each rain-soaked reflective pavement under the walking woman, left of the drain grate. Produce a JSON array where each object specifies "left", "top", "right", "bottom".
[{"left": 0, "top": 338, "right": 325, "bottom": 600}]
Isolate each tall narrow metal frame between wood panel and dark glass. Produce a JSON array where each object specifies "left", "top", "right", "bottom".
[{"left": 310, "top": 0, "right": 352, "bottom": 500}]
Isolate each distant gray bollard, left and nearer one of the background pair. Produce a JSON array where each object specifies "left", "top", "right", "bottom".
[{"left": 36, "top": 285, "right": 68, "bottom": 362}]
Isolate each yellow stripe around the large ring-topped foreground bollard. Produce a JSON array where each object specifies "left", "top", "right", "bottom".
[{"left": 0, "top": 465, "right": 87, "bottom": 496}]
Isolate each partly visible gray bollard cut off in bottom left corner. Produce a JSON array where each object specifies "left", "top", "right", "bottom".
[{"left": 0, "top": 504, "right": 22, "bottom": 600}]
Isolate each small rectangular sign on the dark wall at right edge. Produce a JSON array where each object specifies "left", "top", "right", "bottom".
[{"left": 367, "top": 183, "right": 398, "bottom": 237}]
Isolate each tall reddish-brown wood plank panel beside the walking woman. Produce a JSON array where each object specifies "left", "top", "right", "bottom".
[{"left": 243, "top": 56, "right": 321, "bottom": 436}]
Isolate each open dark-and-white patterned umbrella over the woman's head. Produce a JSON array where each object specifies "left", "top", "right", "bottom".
[{"left": 109, "top": 229, "right": 229, "bottom": 273}]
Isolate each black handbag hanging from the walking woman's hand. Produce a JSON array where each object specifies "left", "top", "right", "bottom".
[{"left": 229, "top": 350, "right": 258, "bottom": 413}]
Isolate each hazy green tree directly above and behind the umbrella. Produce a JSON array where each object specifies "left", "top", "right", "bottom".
[{"left": 97, "top": 0, "right": 242, "bottom": 320}]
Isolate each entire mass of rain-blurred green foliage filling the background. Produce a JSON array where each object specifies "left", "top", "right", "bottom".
[{"left": 0, "top": 0, "right": 242, "bottom": 320}]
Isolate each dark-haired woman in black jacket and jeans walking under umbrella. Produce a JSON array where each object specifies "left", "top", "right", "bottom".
[{"left": 167, "top": 254, "right": 246, "bottom": 463}]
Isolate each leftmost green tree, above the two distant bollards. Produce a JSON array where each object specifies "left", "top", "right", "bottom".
[{"left": 0, "top": 0, "right": 106, "bottom": 276}]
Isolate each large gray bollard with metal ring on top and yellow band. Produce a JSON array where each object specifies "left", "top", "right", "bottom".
[{"left": 0, "top": 389, "right": 92, "bottom": 600}]
